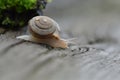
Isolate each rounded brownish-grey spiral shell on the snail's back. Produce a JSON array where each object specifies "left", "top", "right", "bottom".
[{"left": 29, "top": 16, "right": 59, "bottom": 36}]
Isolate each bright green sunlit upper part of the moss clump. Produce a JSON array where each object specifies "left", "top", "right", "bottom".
[{"left": 0, "top": 0, "right": 36, "bottom": 12}]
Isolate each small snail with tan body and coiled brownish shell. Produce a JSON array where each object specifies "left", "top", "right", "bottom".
[{"left": 17, "top": 16, "right": 75, "bottom": 48}]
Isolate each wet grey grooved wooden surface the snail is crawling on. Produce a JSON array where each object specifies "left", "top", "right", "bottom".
[{"left": 0, "top": 32, "right": 120, "bottom": 80}]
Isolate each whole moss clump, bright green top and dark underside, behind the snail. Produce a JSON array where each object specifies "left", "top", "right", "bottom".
[{"left": 0, "top": 0, "right": 51, "bottom": 29}]
